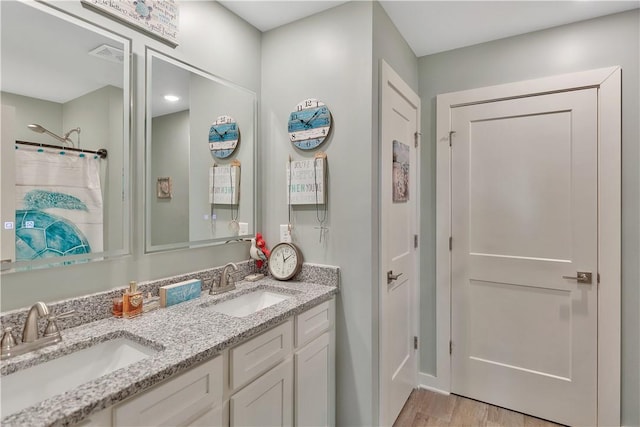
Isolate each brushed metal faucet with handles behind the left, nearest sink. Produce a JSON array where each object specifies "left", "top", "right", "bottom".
[{"left": 0, "top": 301, "right": 75, "bottom": 360}]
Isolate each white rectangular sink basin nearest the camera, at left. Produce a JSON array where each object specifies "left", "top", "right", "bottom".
[{"left": 0, "top": 338, "right": 157, "bottom": 417}]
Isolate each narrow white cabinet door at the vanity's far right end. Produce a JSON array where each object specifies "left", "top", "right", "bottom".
[{"left": 295, "top": 332, "right": 335, "bottom": 427}]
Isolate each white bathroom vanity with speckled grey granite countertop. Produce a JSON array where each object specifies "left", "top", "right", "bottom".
[{"left": 0, "top": 265, "right": 339, "bottom": 426}]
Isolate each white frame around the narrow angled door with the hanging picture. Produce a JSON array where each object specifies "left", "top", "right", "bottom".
[{"left": 376, "top": 59, "right": 422, "bottom": 424}]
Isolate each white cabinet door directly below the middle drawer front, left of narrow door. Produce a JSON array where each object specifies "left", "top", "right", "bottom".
[{"left": 230, "top": 358, "right": 293, "bottom": 427}]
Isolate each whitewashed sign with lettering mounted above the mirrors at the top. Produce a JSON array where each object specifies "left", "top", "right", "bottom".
[{"left": 81, "top": 0, "right": 179, "bottom": 47}]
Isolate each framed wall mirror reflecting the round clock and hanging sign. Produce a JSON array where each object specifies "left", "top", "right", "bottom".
[{"left": 145, "top": 49, "right": 257, "bottom": 252}]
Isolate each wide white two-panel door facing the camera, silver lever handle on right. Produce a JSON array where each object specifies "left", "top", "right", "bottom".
[{"left": 451, "top": 89, "right": 598, "bottom": 425}]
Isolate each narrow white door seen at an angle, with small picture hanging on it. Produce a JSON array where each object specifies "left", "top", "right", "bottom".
[{"left": 380, "top": 64, "right": 420, "bottom": 426}]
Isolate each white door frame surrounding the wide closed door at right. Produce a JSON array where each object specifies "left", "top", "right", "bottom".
[{"left": 430, "top": 66, "right": 622, "bottom": 426}]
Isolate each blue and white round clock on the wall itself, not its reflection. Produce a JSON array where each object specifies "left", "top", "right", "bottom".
[{"left": 289, "top": 98, "right": 331, "bottom": 150}]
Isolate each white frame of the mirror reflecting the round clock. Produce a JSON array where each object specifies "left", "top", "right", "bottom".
[{"left": 144, "top": 46, "right": 259, "bottom": 254}]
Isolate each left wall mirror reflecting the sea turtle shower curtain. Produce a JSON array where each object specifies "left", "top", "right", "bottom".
[{"left": 0, "top": 1, "right": 131, "bottom": 273}]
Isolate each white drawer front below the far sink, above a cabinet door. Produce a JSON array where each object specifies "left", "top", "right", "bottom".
[{"left": 229, "top": 319, "right": 293, "bottom": 390}]
